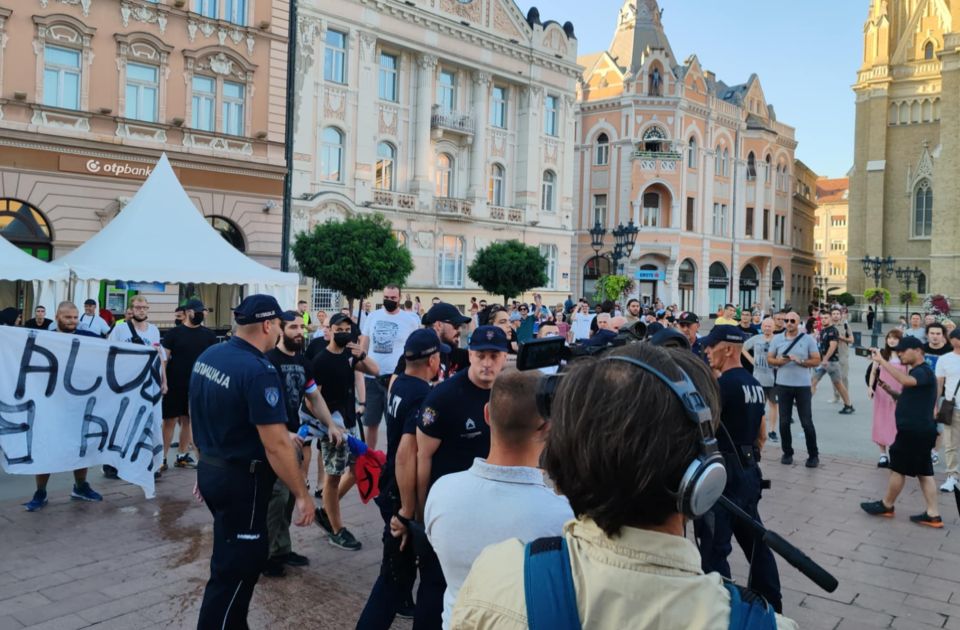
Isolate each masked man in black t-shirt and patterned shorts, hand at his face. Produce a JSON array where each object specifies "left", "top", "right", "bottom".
[{"left": 311, "top": 313, "right": 380, "bottom": 551}]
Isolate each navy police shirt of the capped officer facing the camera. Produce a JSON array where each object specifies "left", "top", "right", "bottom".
[{"left": 417, "top": 370, "right": 490, "bottom": 492}]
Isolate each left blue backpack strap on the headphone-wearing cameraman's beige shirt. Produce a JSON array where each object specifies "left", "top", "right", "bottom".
[{"left": 523, "top": 536, "right": 582, "bottom": 630}]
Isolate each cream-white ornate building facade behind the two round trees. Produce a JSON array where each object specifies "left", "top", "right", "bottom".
[{"left": 291, "top": 0, "right": 579, "bottom": 308}]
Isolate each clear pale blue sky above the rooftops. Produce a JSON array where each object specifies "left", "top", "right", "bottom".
[{"left": 517, "top": 0, "right": 870, "bottom": 177}]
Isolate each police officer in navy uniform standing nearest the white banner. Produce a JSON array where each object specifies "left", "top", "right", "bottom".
[{"left": 190, "top": 295, "right": 313, "bottom": 630}]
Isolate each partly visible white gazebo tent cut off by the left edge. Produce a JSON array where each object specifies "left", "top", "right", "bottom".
[{"left": 0, "top": 236, "right": 70, "bottom": 319}]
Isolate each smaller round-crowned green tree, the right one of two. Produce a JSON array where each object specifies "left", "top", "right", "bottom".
[{"left": 467, "top": 240, "right": 548, "bottom": 303}]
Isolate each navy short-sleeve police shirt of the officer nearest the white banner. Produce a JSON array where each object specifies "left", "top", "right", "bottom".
[{"left": 190, "top": 337, "right": 287, "bottom": 462}]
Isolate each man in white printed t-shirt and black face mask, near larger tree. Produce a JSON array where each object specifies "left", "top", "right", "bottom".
[{"left": 360, "top": 284, "right": 420, "bottom": 449}]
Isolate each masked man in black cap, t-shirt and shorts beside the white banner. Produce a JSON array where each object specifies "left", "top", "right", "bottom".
[{"left": 159, "top": 299, "right": 217, "bottom": 473}]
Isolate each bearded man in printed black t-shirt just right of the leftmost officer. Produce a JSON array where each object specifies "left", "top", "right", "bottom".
[{"left": 263, "top": 311, "right": 342, "bottom": 577}]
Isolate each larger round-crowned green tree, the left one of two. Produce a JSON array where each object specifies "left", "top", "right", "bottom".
[{"left": 292, "top": 214, "right": 413, "bottom": 310}]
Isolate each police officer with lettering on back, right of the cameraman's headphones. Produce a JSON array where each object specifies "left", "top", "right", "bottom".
[{"left": 694, "top": 325, "right": 783, "bottom": 612}]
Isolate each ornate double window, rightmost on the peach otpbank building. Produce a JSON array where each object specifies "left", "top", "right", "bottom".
[{"left": 183, "top": 46, "right": 256, "bottom": 136}]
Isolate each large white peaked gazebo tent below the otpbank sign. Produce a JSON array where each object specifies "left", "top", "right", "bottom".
[{"left": 57, "top": 154, "right": 300, "bottom": 320}]
